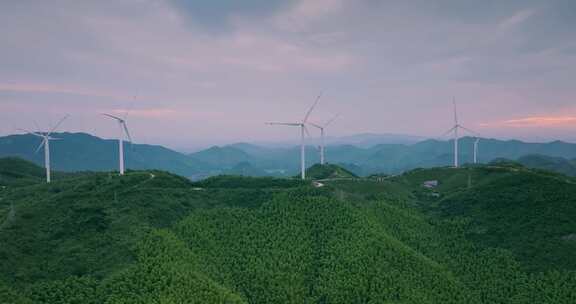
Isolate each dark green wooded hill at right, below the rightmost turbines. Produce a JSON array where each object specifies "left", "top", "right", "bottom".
[{"left": 399, "top": 166, "right": 576, "bottom": 271}]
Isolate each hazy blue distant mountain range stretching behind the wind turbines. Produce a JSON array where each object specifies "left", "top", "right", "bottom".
[{"left": 0, "top": 133, "right": 576, "bottom": 179}]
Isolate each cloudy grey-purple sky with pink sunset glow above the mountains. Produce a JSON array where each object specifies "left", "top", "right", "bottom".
[{"left": 0, "top": 0, "right": 576, "bottom": 150}]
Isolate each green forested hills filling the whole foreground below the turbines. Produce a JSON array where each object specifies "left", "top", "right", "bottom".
[{"left": 0, "top": 158, "right": 576, "bottom": 304}]
